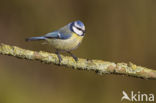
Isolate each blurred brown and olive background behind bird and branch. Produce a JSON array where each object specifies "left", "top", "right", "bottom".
[{"left": 0, "top": 0, "right": 156, "bottom": 103}]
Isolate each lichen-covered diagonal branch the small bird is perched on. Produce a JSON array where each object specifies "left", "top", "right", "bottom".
[{"left": 0, "top": 43, "right": 156, "bottom": 79}]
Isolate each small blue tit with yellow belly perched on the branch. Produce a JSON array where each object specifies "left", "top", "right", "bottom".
[{"left": 26, "top": 20, "right": 85, "bottom": 63}]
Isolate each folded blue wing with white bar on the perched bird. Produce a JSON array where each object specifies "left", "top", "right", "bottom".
[{"left": 44, "top": 31, "right": 71, "bottom": 39}]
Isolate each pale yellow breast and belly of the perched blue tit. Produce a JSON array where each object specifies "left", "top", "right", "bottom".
[{"left": 47, "top": 33, "right": 83, "bottom": 51}]
